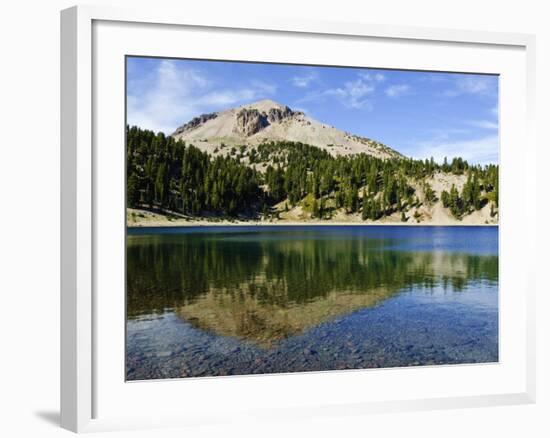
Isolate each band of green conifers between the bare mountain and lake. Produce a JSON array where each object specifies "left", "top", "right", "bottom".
[{"left": 126, "top": 126, "right": 498, "bottom": 221}]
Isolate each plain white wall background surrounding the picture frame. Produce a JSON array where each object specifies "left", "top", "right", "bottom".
[{"left": 0, "top": 0, "right": 550, "bottom": 438}]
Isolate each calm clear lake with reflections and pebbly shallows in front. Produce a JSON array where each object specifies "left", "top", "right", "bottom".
[{"left": 126, "top": 226, "right": 498, "bottom": 380}]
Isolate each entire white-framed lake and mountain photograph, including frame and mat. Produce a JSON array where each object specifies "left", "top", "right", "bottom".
[{"left": 61, "top": 7, "right": 536, "bottom": 431}]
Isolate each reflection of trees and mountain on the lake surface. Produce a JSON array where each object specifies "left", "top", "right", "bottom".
[{"left": 127, "top": 227, "right": 498, "bottom": 348}]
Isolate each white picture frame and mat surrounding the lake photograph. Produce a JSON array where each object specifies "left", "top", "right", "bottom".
[{"left": 61, "top": 6, "right": 536, "bottom": 432}]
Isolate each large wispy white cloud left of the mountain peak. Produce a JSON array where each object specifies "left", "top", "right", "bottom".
[{"left": 127, "top": 60, "right": 275, "bottom": 134}]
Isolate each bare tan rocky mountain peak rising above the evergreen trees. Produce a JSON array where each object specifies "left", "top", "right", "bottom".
[{"left": 172, "top": 99, "right": 402, "bottom": 159}]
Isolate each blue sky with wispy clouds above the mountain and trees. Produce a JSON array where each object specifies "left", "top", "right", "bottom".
[{"left": 127, "top": 57, "right": 498, "bottom": 164}]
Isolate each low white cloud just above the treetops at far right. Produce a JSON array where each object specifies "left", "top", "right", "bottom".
[{"left": 413, "top": 135, "right": 498, "bottom": 164}]
